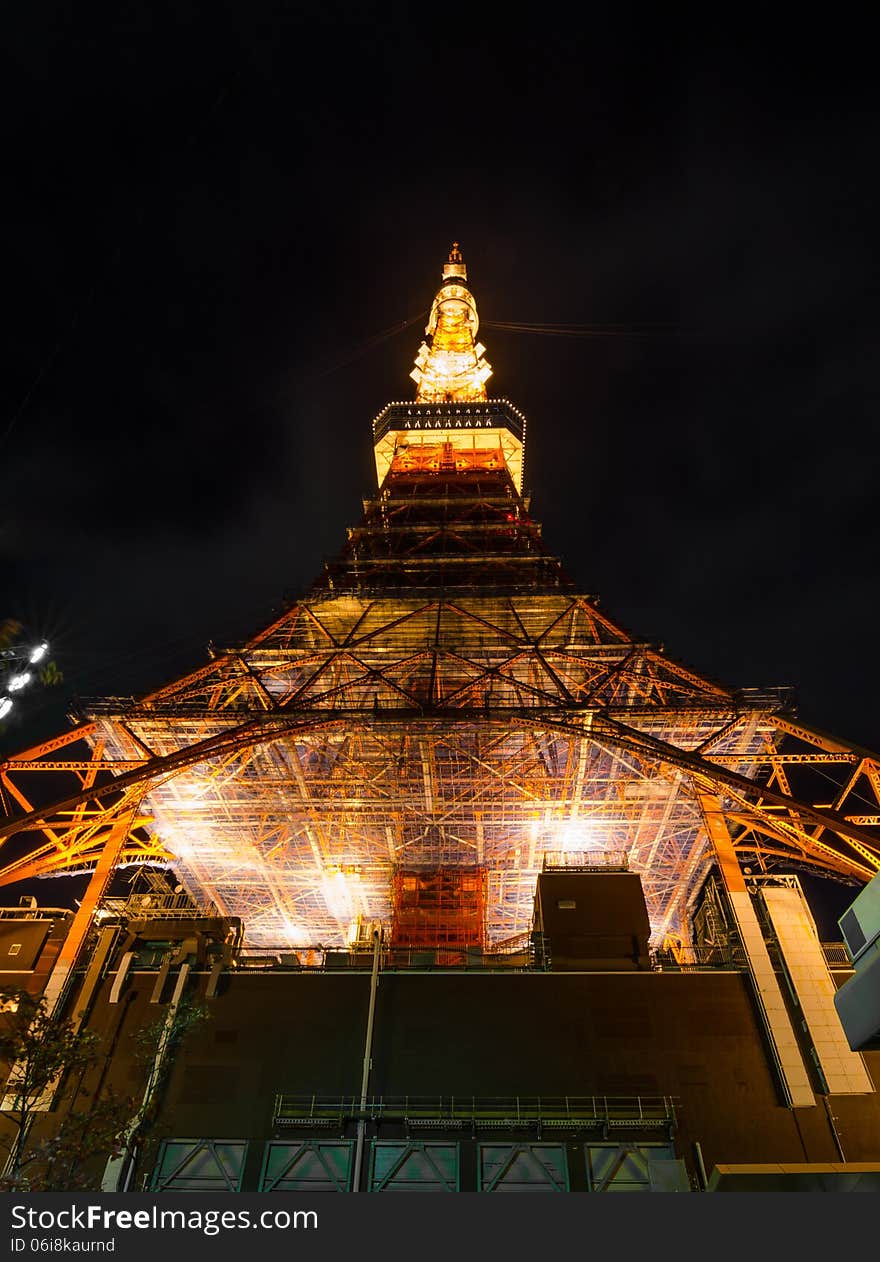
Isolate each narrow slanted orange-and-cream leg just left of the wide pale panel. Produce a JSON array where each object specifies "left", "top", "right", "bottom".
[{"left": 698, "top": 793, "right": 816, "bottom": 1108}]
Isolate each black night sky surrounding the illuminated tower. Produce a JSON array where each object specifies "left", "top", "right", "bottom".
[{"left": 0, "top": 12, "right": 880, "bottom": 928}]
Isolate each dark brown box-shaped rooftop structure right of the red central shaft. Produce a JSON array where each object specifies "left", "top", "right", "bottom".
[{"left": 527, "top": 870, "right": 650, "bottom": 972}]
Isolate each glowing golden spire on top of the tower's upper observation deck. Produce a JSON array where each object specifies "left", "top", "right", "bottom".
[{"left": 409, "top": 241, "right": 492, "bottom": 403}]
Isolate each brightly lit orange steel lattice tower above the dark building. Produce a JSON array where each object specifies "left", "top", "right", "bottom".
[{"left": 0, "top": 246, "right": 880, "bottom": 949}]
